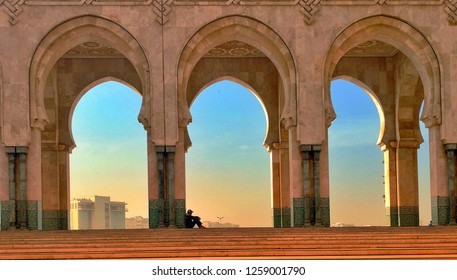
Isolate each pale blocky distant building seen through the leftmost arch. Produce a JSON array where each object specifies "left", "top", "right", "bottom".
[{"left": 70, "top": 195, "right": 128, "bottom": 229}]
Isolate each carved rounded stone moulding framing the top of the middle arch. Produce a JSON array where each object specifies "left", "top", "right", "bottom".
[{"left": 177, "top": 16, "right": 297, "bottom": 130}]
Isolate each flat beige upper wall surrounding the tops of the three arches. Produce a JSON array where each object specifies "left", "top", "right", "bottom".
[{"left": 0, "top": 1, "right": 457, "bottom": 145}]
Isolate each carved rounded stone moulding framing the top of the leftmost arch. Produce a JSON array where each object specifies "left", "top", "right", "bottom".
[{"left": 30, "top": 16, "right": 151, "bottom": 127}]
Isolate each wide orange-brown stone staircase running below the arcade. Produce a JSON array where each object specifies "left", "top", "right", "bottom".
[{"left": 0, "top": 226, "right": 457, "bottom": 259}]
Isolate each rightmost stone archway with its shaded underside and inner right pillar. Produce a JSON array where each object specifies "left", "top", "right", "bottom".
[{"left": 324, "top": 15, "right": 443, "bottom": 226}]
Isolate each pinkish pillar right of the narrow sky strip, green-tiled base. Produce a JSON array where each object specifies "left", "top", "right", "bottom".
[{"left": 428, "top": 125, "right": 448, "bottom": 225}]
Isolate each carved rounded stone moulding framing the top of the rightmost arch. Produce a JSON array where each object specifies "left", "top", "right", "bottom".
[{"left": 324, "top": 15, "right": 441, "bottom": 127}]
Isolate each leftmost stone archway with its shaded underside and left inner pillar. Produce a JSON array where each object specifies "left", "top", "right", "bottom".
[{"left": 27, "top": 16, "right": 151, "bottom": 229}]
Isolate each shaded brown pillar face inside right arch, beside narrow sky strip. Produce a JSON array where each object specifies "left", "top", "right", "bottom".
[{"left": 397, "top": 141, "right": 419, "bottom": 227}]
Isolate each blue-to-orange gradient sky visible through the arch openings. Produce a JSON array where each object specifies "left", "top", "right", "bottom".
[{"left": 70, "top": 80, "right": 431, "bottom": 226}]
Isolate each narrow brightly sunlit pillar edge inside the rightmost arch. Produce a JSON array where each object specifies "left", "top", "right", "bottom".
[{"left": 381, "top": 145, "right": 398, "bottom": 227}]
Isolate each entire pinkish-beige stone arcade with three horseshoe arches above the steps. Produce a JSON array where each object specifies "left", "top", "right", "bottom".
[{"left": 0, "top": 0, "right": 457, "bottom": 229}]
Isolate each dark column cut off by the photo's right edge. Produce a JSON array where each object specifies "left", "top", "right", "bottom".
[{"left": 444, "top": 144, "right": 457, "bottom": 225}]
